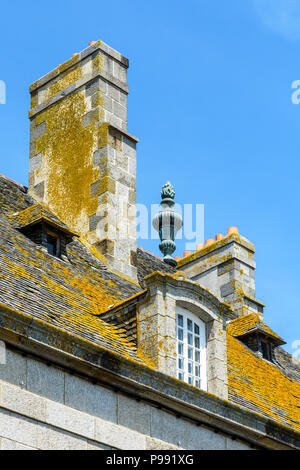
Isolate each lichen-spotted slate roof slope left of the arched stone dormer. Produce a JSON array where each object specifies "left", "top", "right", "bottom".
[{"left": 0, "top": 176, "right": 176, "bottom": 362}]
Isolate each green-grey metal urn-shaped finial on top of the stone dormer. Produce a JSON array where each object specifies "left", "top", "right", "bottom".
[{"left": 152, "top": 181, "right": 182, "bottom": 266}]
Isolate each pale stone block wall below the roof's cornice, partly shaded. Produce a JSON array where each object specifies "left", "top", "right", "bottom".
[{"left": 0, "top": 349, "right": 251, "bottom": 450}]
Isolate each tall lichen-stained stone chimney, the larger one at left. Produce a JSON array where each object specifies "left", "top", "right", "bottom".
[{"left": 29, "top": 41, "right": 137, "bottom": 280}]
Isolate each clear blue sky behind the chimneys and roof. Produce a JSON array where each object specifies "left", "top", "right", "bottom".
[{"left": 0, "top": 0, "right": 300, "bottom": 351}]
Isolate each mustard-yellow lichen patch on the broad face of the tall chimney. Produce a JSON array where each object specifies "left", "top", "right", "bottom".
[{"left": 35, "top": 92, "right": 99, "bottom": 236}]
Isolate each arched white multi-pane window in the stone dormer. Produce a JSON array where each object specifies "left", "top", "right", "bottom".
[{"left": 176, "top": 306, "right": 207, "bottom": 390}]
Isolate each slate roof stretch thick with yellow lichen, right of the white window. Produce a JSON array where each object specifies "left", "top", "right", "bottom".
[{"left": 227, "top": 333, "right": 300, "bottom": 432}]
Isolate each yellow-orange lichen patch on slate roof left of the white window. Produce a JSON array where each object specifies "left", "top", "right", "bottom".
[{"left": 1, "top": 229, "right": 148, "bottom": 359}]
